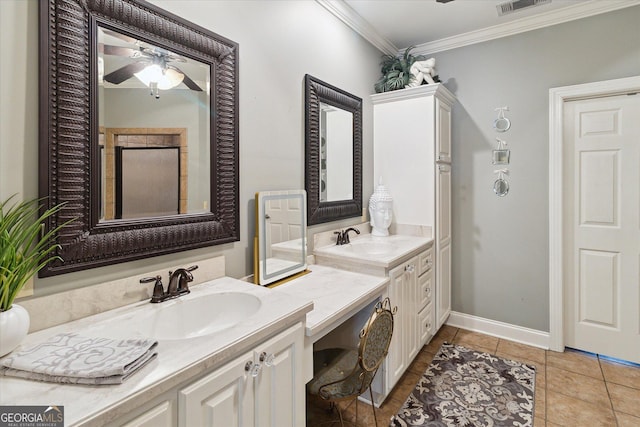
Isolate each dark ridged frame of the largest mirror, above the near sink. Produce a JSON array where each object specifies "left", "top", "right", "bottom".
[{"left": 39, "top": 0, "right": 240, "bottom": 277}]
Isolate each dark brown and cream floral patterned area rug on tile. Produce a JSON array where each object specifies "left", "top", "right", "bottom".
[{"left": 390, "top": 343, "right": 536, "bottom": 427}]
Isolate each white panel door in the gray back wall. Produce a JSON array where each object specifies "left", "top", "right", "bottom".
[{"left": 563, "top": 95, "right": 640, "bottom": 363}]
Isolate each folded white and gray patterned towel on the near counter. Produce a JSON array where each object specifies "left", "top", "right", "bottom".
[{"left": 0, "top": 333, "right": 158, "bottom": 384}]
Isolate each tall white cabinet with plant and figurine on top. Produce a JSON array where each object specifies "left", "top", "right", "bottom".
[{"left": 371, "top": 83, "right": 455, "bottom": 330}]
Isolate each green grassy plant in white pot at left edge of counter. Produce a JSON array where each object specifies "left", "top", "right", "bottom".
[{"left": 0, "top": 194, "right": 68, "bottom": 357}]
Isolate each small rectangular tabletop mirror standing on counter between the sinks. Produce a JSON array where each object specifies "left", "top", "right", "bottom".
[{"left": 254, "top": 190, "right": 307, "bottom": 285}]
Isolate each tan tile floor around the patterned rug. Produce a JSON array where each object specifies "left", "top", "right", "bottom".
[{"left": 307, "top": 326, "right": 640, "bottom": 427}]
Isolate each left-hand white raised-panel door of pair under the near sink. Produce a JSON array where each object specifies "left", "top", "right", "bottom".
[{"left": 178, "top": 352, "right": 254, "bottom": 427}]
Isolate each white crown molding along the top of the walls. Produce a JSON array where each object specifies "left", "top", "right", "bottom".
[{"left": 316, "top": 0, "right": 640, "bottom": 55}]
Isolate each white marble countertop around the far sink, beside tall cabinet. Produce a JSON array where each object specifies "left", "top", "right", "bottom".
[{"left": 314, "top": 234, "right": 433, "bottom": 271}]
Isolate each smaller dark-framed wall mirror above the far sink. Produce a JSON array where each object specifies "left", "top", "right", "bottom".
[{"left": 305, "top": 74, "right": 362, "bottom": 225}]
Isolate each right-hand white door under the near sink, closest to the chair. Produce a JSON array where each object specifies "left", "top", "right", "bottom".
[{"left": 254, "top": 323, "right": 305, "bottom": 427}]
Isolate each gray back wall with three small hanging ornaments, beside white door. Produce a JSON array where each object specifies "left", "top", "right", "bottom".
[{"left": 433, "top": 7, "right": 640, "bottom": 331}]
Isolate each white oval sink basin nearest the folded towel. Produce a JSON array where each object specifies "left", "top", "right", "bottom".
[{"left": 82, "top": 292, "right": 262, "bottom": 340}]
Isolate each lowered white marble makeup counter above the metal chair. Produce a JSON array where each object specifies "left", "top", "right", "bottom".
[{"left": 273, "top": 264, "right": 389, "bottom": 342}]
